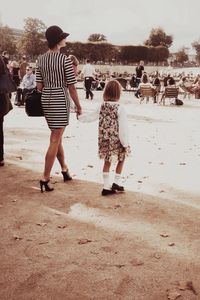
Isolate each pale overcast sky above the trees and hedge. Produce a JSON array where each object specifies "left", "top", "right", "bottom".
[{"left": 0, "top": 0, "right": 200, "bottom": 53}]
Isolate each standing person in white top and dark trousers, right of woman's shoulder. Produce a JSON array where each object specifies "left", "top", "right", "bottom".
[{"left": 81, "top": 59, "right": 96, "bottom": 100}]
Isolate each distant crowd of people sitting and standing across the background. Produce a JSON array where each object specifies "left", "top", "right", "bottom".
[{"left": 2, "top": 51, "right": 200, "bottom": 106}]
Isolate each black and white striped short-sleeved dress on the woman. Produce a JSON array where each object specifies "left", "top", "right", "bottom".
[{"left": 36, "top": 52, "right": 76, "bottom": 130}]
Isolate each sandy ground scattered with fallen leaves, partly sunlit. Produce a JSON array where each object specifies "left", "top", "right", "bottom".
[{"left": 0, "top": 90, "right": 200, "bottom": 300}]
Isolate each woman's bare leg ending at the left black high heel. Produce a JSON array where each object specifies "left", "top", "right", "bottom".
[{"left": 43, "top": 128, "right": 65, "bottom": 181}]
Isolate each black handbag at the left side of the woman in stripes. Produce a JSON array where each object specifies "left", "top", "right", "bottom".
[{"left": 25, "top": 89, "right": 44, "bottom": 117}]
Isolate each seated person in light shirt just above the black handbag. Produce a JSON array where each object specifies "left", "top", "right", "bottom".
[{"left": 17, "top": 66, "right": 36, "bottom": 106}]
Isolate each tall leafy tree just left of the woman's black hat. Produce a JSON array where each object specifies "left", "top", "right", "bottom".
[{"left": 17, "top": 18, "right": 47, "bottom": 56}]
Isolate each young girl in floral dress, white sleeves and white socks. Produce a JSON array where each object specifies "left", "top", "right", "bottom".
[{"left": 79, "top": 80, "right": 130, "bottom": 196}]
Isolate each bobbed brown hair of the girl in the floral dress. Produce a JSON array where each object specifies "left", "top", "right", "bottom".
[{"left": 103, "top": 79, "right": 122, "bottom": 101}]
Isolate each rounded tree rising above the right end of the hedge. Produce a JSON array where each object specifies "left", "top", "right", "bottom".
[{"left": 145, "top": 27, "right": 173, "bottom": 48}]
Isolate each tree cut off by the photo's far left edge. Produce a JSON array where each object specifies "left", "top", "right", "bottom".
[{"left": 0, "top": 25, "right": 16, "bottom": 54}]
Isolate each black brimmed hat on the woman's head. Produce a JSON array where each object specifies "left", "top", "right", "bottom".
[{"left": 45, "top": 25, "right": 69, "bottom": 48}]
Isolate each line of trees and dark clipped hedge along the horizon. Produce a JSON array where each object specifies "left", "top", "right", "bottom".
[{"left": 0, "top": 18, "right": 200, "bottom": 64}]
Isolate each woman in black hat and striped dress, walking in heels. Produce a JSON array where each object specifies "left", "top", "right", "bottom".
[{"left": 36, "top": 26, "right": 81, "bottom": 192}]
